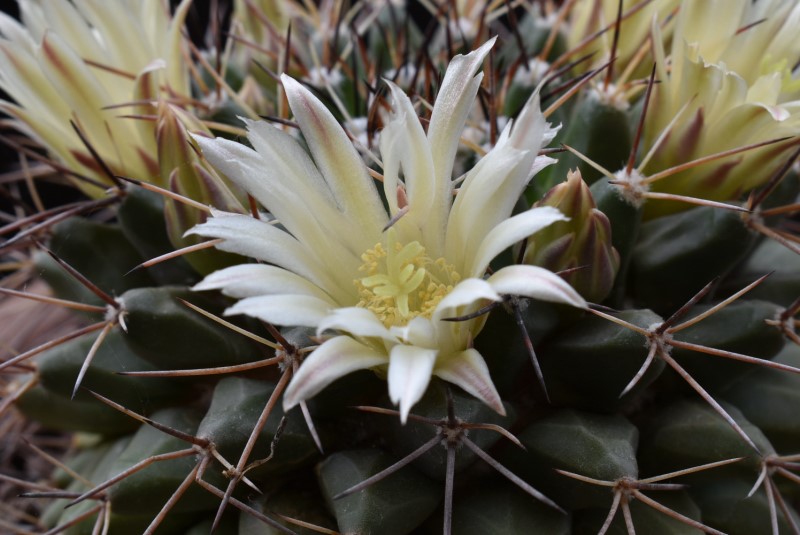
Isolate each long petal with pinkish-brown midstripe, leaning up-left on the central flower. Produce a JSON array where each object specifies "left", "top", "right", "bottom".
[{"left": 281, "top": 74, "right": 388, "bottom": 232}]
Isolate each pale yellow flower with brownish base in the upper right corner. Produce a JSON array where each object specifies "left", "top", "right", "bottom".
[{"left": 642, "top": 0, "right": 800, "bottom": 217}]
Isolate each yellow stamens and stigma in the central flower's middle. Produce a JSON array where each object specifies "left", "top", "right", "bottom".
[{"left": 353, "top": 228, "right": 461, "bottom": 327}]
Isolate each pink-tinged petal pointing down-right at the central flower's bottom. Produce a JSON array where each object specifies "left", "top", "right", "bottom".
[{"left": 433, "top": 348, "right": 506, "bottom": 416}]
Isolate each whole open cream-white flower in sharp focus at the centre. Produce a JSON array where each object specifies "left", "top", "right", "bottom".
[{"left": 192, "top": 42, "right": 586, "bottom": 421}]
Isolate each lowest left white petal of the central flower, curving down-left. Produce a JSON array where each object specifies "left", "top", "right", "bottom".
[{"left": 283, "top": 336, "right": 388, "bottom": 411}]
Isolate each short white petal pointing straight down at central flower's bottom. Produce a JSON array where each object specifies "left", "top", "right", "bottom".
[{"left": 388, "top": 344, "right": 438, "bottom": 423}]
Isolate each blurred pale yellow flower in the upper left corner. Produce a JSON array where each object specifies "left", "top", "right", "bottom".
[{"left": 0, "top": 0, "right": 191, "bottom": 196}]
